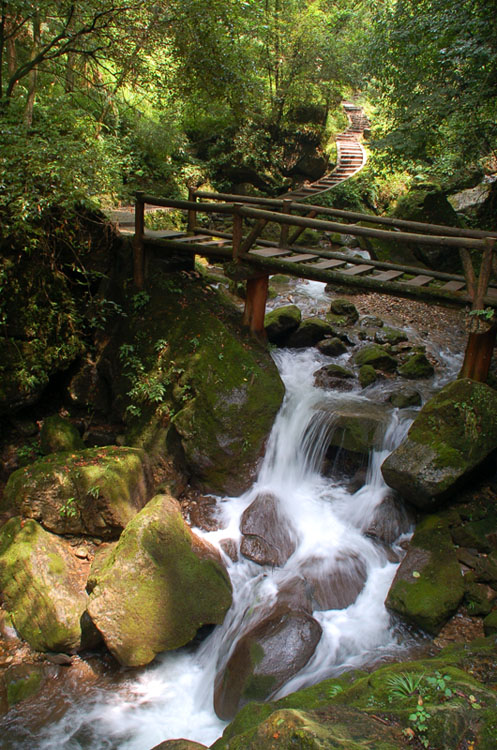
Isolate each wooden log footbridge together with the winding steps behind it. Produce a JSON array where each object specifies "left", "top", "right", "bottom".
[{"left": 123, "top": 103, "right": 497, "bottom": 381}]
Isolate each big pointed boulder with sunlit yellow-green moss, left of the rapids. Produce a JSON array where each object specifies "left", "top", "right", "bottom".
[{"left": 88, "top": 495, "right": 231, "bottom": 667}]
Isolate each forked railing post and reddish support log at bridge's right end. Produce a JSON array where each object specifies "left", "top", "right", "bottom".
[{"left": 459, "top": 238, "right": 497, "bottom": 383}]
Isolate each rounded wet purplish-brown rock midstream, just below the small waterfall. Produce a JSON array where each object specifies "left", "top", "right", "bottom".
[{"left": 240, "top": 493, "right": 297, "bottom": 565}]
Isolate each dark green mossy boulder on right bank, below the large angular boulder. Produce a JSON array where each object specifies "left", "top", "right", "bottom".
[{"left": 385, "top": 515, "right": 465, "bottom": 634}]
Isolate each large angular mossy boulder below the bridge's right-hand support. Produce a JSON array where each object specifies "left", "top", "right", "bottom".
[{"left": 381, "top": 379, "right": 497, "bottom": 509}]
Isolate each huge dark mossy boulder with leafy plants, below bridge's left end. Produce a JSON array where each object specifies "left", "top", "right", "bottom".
[{"left": 100, "top": 272, "right": 284, "bottom": 495}]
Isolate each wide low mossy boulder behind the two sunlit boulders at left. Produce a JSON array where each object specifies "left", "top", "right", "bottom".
[{"left": 2, "top": 446, "right": 151, "bottom": 539}]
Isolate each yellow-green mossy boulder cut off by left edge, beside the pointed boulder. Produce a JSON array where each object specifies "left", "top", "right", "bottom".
[{"left": 0, "top": 517, "right": 98, "bottom": 653}]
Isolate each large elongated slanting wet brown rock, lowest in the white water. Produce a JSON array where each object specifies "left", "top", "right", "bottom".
[{"left": 214, "top": 608, "right": 322, "bottom": 719}]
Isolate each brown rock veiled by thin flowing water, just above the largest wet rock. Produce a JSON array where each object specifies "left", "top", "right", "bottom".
[{"left": 301, "top": 553, "right": 367, "bottom": 610}]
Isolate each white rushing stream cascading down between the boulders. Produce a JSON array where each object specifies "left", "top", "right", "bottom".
[{"left": 0, "top": 282, "right": 459, "bottom": 750}]
